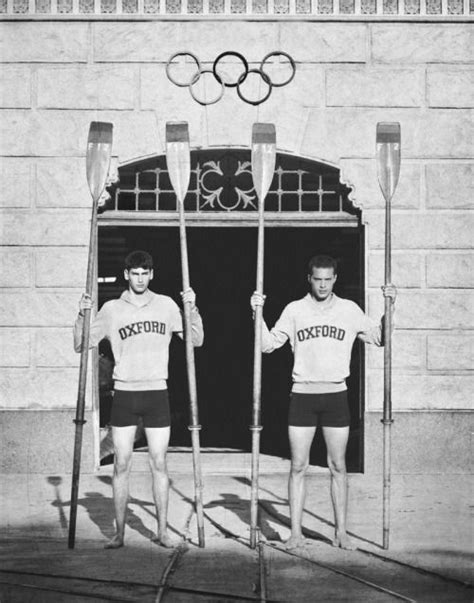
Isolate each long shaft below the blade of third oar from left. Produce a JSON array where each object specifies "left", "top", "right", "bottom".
[{"left": 250, "top": 206, "right": 265, "bottom": 548}]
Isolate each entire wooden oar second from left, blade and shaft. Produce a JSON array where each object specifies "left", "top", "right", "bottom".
[{"left": 166, "top": 122, "right": 205, "bottom": 547}]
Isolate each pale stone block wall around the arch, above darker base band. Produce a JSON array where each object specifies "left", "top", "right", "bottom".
[{"left": 0, "top": 20, "right": 474, "bottom": 470}]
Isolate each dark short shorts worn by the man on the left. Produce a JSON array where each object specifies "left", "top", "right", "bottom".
[{"left": 110, "top": 389, "right": 170, "bottom": 427}]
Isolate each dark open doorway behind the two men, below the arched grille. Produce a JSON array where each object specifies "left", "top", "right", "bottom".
[{"left": 99, "top": 226, "right": 364, "bottom": 471}]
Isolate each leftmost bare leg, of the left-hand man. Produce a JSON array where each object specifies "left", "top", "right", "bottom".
[{"left": 104, "top": 425, "right": 136, "bottom": 549}]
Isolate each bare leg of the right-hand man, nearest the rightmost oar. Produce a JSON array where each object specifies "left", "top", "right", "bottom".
[{"left": 323, "top": 427, "right": 355, "bottom": 550}]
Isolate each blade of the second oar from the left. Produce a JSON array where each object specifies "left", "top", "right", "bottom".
[{"left": 166, "top": 121, "right": 191, "bottom": 203}]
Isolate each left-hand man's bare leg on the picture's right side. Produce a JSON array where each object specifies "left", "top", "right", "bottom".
[{"left": 145, "top": 427, "right": 177, "bottom": 547}]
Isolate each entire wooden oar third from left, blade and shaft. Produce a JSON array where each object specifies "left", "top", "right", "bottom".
[{"left": 250, "top": 123, "right": 276, "bottom": 549}]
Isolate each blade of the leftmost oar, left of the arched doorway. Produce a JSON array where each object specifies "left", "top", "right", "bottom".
[{"left": 86, "top": 121, "right": 113, "bottom": 202}]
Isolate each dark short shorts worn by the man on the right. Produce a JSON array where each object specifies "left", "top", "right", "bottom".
[{"left": 288, "top": 390, "right": 351, "bottom": 427}]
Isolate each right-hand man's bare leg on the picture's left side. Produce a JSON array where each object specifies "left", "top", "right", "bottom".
[{"left": 285, "top": 425, "right": 316, "bottom": 549}]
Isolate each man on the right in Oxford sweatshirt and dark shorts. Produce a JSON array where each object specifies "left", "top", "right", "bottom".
[{"left": 251, "top": 255, "right": 396, "bottom": 549}]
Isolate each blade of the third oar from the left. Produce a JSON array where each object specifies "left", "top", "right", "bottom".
[{"left": 252, "top": 123, "right": 276, "bottom": 203}]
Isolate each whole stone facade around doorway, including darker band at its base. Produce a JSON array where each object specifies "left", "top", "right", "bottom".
[{"left": 0, "top": 5, "right": 474, "bottom": 473}]
